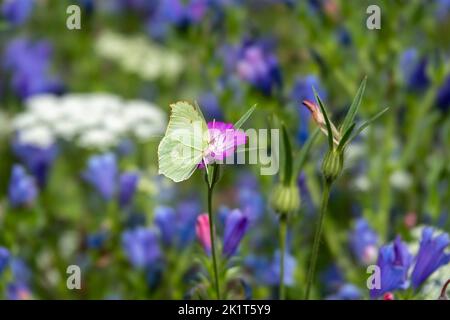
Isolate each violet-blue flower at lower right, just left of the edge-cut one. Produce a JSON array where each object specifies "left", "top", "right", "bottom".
[{"left": 370, "top": 237, "right": 413, "bottom": 298}]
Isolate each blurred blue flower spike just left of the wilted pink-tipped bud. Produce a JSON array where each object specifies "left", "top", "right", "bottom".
[{"left": 290, "top": 74, "right": 327, "bottom": 144}]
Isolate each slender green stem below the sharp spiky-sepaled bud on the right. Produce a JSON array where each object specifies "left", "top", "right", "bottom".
[{"left": 305, "top": 180, "right": 332, "bottom": 300}]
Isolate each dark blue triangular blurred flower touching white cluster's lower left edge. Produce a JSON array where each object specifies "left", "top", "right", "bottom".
[{"left": 12, "top": 141, "right": 58, "bottom": 188}]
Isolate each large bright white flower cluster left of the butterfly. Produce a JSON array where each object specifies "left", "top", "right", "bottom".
[{"left": 12, "top": 93, "right": 166, "bottom": 149}]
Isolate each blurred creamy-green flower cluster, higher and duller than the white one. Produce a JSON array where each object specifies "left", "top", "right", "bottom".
[{"left": 95, "top": 31, "right": 183, "bottom": 80}]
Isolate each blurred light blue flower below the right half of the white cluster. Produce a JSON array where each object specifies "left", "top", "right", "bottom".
[{"left": 83, "top": 153, "right": 118, "bottom": 201}]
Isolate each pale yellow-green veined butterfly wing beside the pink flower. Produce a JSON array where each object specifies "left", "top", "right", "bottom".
[{"left": 158, "top": 102, "right": 209, "bottom": 182}]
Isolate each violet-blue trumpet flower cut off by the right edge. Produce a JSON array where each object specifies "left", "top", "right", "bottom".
[{"left": 411, "top": 227, "right": 450, "bottom": 289}]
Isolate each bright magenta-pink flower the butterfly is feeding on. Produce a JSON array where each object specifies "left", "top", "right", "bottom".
[{"left": 199, "top": 121, "right": 247, "bottom": 168}]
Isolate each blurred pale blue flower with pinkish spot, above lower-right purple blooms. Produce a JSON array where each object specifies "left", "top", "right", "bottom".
[{"left": 349, "top": 218, "right": 378, "bottom": 265}]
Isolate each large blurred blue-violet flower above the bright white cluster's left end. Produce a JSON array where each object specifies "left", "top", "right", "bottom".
[{"left": 3, "top": 38, "right": 63, "bottom": 98}]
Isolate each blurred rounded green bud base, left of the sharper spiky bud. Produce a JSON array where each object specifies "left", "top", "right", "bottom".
[{"left": 271, "top": 184, "right": 300, "bottom": 214}]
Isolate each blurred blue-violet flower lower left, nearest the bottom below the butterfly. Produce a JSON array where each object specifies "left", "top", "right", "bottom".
[{"left": 122, "top": 227, "right": 161, "bottom": 268}]
